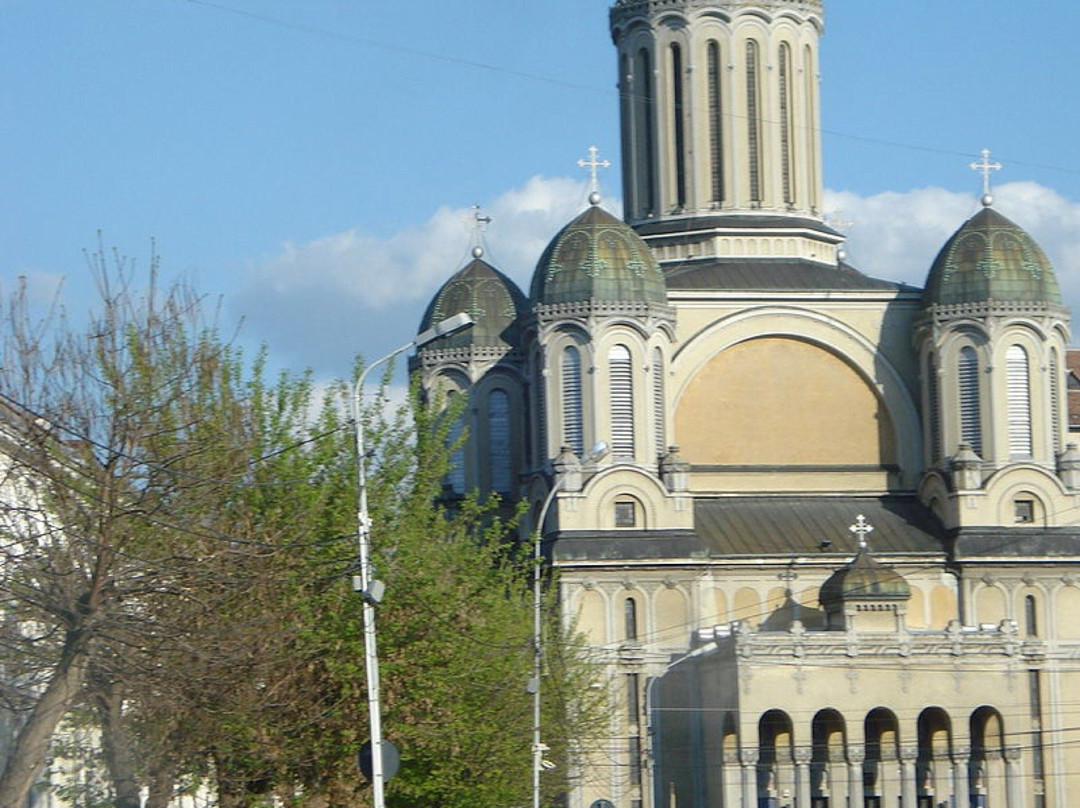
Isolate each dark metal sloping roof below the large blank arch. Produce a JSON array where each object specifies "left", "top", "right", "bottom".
[{"left": 693, "top": 497, "right": 944, "bottom": 555}]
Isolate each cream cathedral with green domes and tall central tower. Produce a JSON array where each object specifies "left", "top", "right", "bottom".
[{"left": 413, "top": 0, "right": 1080, "bottom": 808}]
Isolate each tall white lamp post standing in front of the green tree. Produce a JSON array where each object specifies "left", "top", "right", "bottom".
[{"left": 352, "top": 312, "right": 473, "bottom": 808}]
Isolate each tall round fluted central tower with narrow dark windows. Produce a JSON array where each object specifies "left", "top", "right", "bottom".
[{"left": 610, "top": 0, "right": 840, "bottom": 264}]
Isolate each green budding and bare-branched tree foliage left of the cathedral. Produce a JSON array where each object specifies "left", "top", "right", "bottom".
[{"left": 0, "top": 246, "right": 588, "bottom": 808}]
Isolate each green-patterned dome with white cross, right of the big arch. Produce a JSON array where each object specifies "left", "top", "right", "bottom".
[{"left": 922, "top": 207, "right": 1062, "bottom": 306}]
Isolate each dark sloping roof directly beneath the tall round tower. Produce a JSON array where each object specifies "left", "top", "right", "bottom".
[{"left": 664, "top": 258, "right": 914, "bottom": 292}]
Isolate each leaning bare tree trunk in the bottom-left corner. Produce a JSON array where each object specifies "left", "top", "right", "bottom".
[{"left": 0, "top": 629, "right": 89, "bottom": 808}]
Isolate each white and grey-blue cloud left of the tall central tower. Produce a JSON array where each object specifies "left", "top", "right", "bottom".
[{"left": 230, "top": 176, "right": 600, "bottom": 376}]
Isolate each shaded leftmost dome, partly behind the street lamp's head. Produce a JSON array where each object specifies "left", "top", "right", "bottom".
[{"left": 418, "top": 257, "right": 526, "bottom": 350}]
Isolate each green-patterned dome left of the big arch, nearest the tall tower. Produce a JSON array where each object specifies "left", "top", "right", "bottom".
[{"left": 531, "top": 205, "right": 667, "bottom": 305}]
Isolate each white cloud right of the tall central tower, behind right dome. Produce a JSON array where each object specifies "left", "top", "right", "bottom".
[{"left": 825, "top": 183, "right": 1080, "bottom": 314}]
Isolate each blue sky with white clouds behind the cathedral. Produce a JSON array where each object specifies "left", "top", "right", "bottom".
[{"left": 0, "top": 0, "right": 1080, "bottom": 375}]
